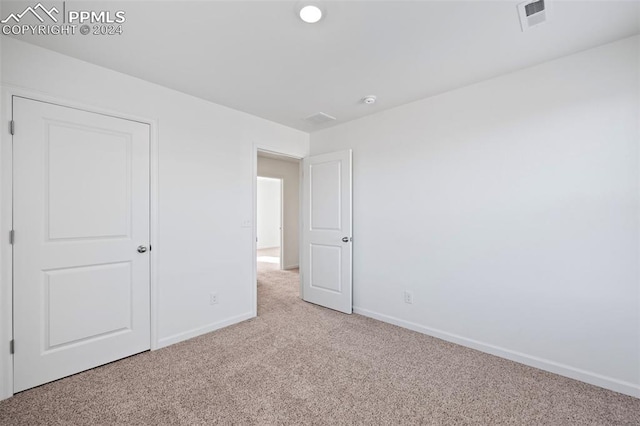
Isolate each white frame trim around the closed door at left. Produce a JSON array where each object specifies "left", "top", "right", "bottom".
[{"left": 0, "top": 84, "right": 160, "bottom": 400}]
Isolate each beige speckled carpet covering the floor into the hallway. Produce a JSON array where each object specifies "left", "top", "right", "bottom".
[{"left": 0, "top": 270, "right": 640, "bottom": 425}]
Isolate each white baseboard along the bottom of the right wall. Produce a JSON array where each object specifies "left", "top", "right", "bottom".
[{"left": 353, "top": 306, "right": 640, "bottom": 398}]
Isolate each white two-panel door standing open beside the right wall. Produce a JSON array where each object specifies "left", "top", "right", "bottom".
[{"left": 301, "top": 150, "right": 352, "bottom": 314}]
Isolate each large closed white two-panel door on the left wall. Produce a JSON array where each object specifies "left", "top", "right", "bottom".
[{"left": 13, "top": 97, "right": 150, "bottom": 392}]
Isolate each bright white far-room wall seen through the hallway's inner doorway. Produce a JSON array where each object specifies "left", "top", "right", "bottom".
[{"left": 256, "top": 177, "right": 282, "bottom": 249}]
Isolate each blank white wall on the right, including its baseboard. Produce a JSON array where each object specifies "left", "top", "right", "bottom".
[{"left": 311, "top": 37, "right": 640, "bottom": 396}]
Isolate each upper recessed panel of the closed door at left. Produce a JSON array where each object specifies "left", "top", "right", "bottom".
[{"left": 45, "top": 125, "right": 132, "bottom": 240}]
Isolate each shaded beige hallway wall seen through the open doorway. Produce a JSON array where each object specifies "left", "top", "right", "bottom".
[{"left": 258, "top": 157, "right": 300, "bottom": 269}]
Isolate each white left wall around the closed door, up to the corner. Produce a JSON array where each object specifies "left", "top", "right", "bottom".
[{"left": 0, "top": 36, "right": 309, "bottom": 399}]
